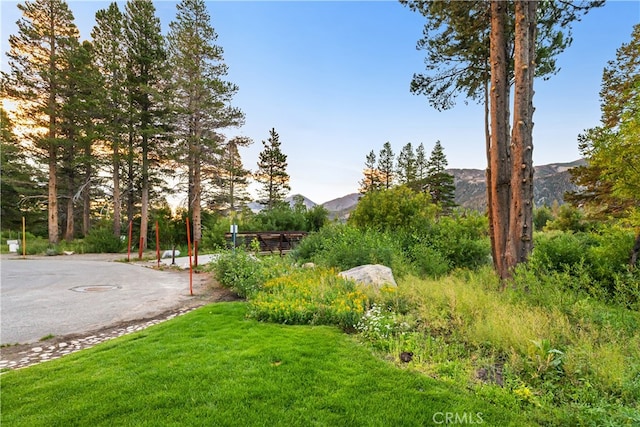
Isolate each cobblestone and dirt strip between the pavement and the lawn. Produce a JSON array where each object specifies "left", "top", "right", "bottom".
[{"left": 0, "top": 273, "right": 242, "bottom": 369}]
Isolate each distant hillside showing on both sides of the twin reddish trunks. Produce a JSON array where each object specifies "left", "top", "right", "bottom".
[{"left": 448, "top": 160, "right": 585, "bottom": 210}]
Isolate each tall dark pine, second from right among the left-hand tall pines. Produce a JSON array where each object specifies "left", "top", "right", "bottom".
[{"left": 124, "top": 0, "right": 168, "bottom": 248}]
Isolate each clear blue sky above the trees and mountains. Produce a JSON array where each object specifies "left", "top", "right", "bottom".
[{"left": 1, "top": 0, "right": 640, "bottom": 203}]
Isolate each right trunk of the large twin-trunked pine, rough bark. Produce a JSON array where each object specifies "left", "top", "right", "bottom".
[{"left": 505, "top": 0, "right": 537, "bottom": 271}]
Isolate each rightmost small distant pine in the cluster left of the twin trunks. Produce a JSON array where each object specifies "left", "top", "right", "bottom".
[{"left": 426, "top": 141, "right": 456, "bottom": 214}]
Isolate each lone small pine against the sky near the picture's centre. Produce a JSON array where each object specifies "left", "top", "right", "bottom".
[{"left": 256, "top": 128, "right": 291, "bottom": 209}]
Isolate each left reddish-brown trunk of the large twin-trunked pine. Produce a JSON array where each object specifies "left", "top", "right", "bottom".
[{"left": 487, "top": 1, "right": 511, "bottom": 279}]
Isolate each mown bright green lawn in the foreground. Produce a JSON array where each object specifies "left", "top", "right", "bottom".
[{"left": 0, "top": 303, "right": 530, "bottom": 426}]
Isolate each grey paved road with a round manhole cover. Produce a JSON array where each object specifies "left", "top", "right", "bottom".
[{"left": 0, "top": 255, "right": 201, "bottom": 344}]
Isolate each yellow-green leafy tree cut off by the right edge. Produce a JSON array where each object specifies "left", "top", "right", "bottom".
[{"left": 567, "top": 24, "right": 640, "bottom": 266}]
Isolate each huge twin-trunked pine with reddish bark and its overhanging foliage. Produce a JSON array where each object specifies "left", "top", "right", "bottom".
[{"left": 401, "top": 0, "right": 604, "bottom": 278}]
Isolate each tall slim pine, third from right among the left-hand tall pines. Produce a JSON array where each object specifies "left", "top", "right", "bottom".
[{"left": 91, "top": 2, "right": 127, "bottom": 237}]
